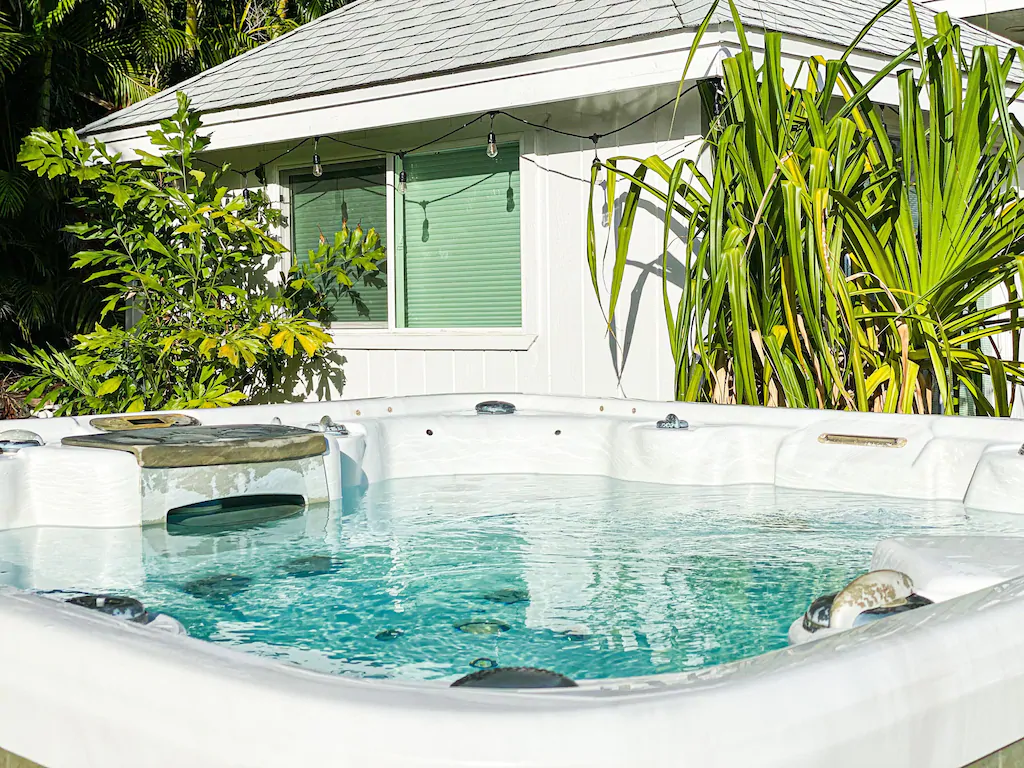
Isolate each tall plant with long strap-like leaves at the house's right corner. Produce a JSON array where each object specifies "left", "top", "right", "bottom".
[{"left": 588, "top": 0, "right": 1024, "bottom": 415}]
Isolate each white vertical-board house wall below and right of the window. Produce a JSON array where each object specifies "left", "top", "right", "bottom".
[{"left": 212, "top": 88, "right": 700, "bottom": 399}]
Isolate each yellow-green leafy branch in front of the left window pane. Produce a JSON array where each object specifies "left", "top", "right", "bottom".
[{"left": 282, "top": 227, "right": 387, "bottom": 325}]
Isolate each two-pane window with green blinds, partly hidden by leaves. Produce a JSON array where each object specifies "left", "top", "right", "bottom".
[{"left": 288, "top": 143, "right": 522, "bottom": 329}]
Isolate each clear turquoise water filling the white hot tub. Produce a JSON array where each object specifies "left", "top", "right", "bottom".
[{"left": 0, "top": 475, "right": 1024, "bottom": 680}]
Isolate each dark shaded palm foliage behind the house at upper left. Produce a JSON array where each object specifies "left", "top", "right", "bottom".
[{"left": 0, "top": 0, "right": 345, "bottom": 358}]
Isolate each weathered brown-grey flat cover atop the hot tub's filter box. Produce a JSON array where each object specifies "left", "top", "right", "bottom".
[{"left": 61, "top": 424, "right": 327, "bottom": 468}]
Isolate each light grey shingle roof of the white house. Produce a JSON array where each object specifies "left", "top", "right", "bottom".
[{"left": 83, "top": 0, "right": 1006, "bottom": 134}]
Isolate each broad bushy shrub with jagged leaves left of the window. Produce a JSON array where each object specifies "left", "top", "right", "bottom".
[{"left": 6, "top": 94, "right": 330, "bottom": 414}]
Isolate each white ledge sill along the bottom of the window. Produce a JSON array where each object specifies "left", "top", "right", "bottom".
[{"left": 329, "top": 328, "right": 537, "bottom": 351}]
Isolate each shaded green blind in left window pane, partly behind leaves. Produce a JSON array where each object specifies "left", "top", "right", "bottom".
[{"left": 290, "top": 161, "right": 387, "bottom": 323}]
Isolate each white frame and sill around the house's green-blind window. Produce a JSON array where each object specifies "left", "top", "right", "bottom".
[{"left": 270, "top": 133, "right": 537, "bottom": 350}]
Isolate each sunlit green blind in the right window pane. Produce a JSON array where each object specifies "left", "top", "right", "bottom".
[{"left": 397, "top": 143, "right": 522, "bottom": 328}]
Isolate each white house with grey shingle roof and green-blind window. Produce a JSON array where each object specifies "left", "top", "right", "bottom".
[{"left": 85, "top": 0, "right": 1005, "bottom": 399}]
